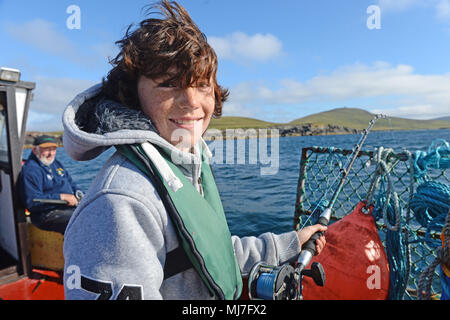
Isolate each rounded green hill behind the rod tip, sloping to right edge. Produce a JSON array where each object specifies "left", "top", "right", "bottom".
[{"left": 290, "top": 108, "right": 450, "bottom": 130}]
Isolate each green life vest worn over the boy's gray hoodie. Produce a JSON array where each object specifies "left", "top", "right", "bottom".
[{"left": 116, "top": 145, "right": 243, "bottom": 300}]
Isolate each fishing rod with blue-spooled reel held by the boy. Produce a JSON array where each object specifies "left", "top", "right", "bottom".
[{"left": 248, "top": 114, "right": 386, "bottom": 300}]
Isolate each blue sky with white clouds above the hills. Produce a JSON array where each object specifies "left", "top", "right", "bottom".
[{"left": 0, "top": 0, "right": 450, "bottom": 131}]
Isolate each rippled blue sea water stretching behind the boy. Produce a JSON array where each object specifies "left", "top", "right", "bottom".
[{"left": 23, "top": 129, "right": 450, "bottom": 236}]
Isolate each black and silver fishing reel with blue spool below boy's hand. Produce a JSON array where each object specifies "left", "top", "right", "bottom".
[{"left": 248, "top": 262, "right": 325, "bottom": 300}]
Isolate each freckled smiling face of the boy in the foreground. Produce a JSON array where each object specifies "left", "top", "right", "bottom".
[{"left": 137, "top": 76, "right": 215, "bottom": 152}]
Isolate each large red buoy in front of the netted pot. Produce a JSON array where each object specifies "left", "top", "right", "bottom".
[{"left": 303, "top": 202, "right": 389, "bottom": 300}]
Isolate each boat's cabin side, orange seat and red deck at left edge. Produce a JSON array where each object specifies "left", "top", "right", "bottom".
[{"left": 0, "top": 68, "right": 64, "bottom": 300}]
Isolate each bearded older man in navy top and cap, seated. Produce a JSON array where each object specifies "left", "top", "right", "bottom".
[{"left": 18, "top": 135, "right": 82, "bottom": 234}]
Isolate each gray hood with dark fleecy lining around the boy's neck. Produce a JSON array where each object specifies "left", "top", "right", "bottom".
[{"left": 62, "top": 84, "right": 211, "bottom": 182}]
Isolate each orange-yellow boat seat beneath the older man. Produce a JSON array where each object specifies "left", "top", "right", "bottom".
[{"left": 27, "top": 222, "right": 64, "bottom": 271}]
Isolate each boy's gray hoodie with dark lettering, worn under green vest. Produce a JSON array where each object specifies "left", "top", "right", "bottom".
[{"left": 63, "top": 85, "right": 300, "bottom": 300}]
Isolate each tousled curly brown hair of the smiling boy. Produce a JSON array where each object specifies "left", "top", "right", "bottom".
[{"left": 102, "top": 0, "right": 229, "bottom": 117}]
